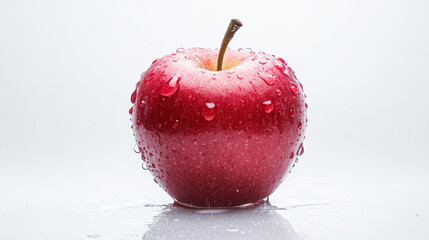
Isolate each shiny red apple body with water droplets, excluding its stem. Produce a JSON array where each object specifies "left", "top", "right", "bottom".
[{"left": 130, "top": 48, "right": 307, "bottom": 207}]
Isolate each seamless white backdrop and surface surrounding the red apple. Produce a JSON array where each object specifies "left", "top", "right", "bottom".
[{"left": 0, "top": 0, "right": 429, "bottom": 239}]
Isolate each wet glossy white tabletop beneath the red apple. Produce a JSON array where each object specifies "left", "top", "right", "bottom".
[{"left": 0, "top": 165, "right": 429, "bottom": 240}]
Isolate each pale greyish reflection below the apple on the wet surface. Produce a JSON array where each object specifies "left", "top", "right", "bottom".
[{"left": 142, "top": 202, "right": 299, "bottom": 240}]
